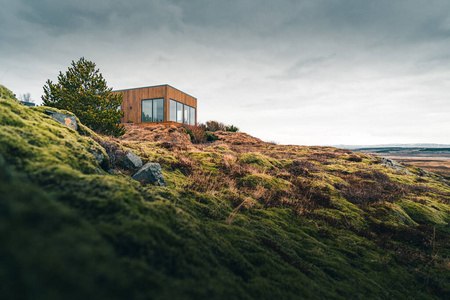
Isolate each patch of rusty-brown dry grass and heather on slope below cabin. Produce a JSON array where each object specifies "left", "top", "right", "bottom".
[{"left": 115, "top": 127, "right": 448, "bottom": 217}]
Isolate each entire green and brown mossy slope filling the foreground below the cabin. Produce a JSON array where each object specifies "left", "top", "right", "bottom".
[{"left": 0, "top": 88, "right": 450, "bottom": 299}]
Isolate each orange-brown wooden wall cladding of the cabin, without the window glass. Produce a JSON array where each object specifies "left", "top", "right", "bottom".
[{"left": 113, "top": 85, "right": 197, "bottom": 124}]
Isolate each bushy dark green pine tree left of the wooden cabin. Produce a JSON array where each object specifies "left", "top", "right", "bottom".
[{"left": 42, "top": 57, "right": 125, "bottom": 136}]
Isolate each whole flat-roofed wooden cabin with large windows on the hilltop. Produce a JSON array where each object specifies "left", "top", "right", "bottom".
[{"left": 113, "top": 84, "right": 197, "bottom": 125}]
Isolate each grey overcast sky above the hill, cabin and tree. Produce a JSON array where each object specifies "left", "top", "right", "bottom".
[{"left": 0, "top": 0, "right": 450, "bottom": 145}]
